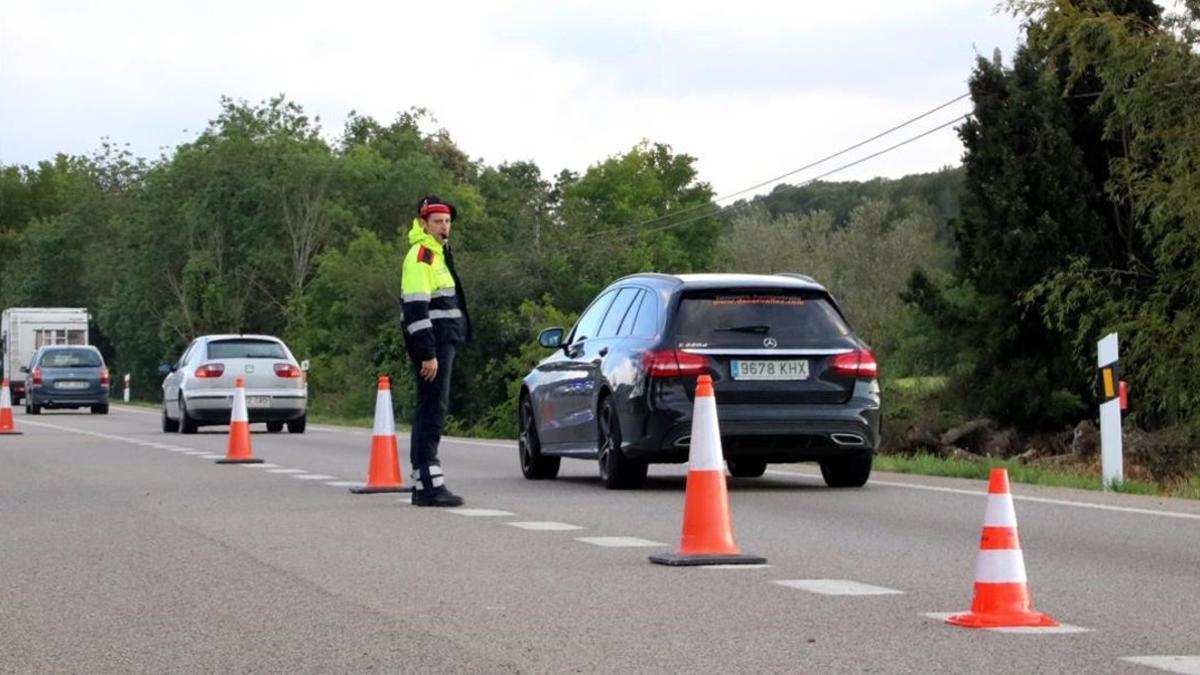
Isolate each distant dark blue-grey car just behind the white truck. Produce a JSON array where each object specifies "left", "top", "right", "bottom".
[{"left": 23, "top": 347, "right": 109, "bottom": 414}]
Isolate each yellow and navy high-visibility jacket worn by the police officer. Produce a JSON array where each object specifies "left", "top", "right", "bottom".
[{"left": 400, "top": 219, "right": 470, "bottom": 362}]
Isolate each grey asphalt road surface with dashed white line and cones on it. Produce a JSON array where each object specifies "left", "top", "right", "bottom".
[{"left": 0, "top": 406, "right": 1200, "bottom": 674}]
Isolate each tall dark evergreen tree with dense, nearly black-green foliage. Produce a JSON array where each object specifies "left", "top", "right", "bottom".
[{"left": 907, "top": 0, "right": 1158, "bottom": 428}]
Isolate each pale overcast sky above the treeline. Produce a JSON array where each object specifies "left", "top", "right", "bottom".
[{"left": 0, "top": 0, "right": 1020, "bottom": 195}]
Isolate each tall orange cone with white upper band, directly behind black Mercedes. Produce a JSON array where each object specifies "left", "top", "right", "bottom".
[{"left": 650, "top": 375, "right": 767, "bottom": 566}]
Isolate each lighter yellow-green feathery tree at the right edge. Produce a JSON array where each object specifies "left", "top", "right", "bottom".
[{"left": 1013, "top": 1, "right": 1200, "bottom": 429}]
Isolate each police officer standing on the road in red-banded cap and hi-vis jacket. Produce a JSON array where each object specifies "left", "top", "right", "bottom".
[{"left": 400, "top": 195, "right": 470, "bottom": 507}]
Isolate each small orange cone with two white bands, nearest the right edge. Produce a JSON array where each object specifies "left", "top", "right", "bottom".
[{"left": 946, "top": 468, "right": 1058, "bottom": 628}]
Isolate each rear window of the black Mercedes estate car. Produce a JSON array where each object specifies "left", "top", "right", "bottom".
[{"left": 674, "top": 289, "right": 851, "bottom": 344}]
